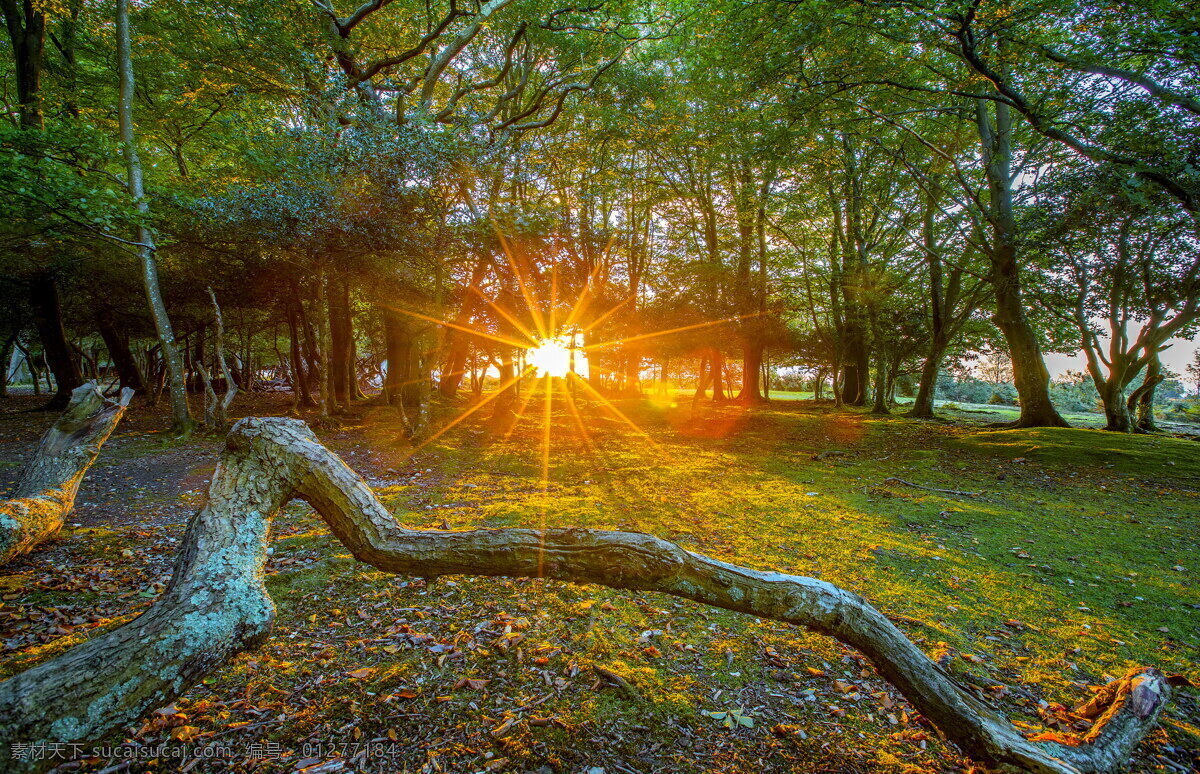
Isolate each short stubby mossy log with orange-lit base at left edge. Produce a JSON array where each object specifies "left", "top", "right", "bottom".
[{"left": 0, "top": 382, "right": 133, "bottom": 564}]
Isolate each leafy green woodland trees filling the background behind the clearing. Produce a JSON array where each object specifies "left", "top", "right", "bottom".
[{"left": 0, "top": 0, "right": 1200, "bottom": 432}]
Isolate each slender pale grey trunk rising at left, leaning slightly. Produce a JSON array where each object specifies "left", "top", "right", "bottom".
[{"left": 116, "top": 0, "right": 192, "bottom": 433}]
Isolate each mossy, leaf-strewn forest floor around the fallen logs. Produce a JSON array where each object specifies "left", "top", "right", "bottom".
[{"left": 0, "top": 386, "right": 1200, "bottom": 774}]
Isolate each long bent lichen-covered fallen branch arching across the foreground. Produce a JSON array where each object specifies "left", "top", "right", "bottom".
[{"left": 0, "top": 418, "right": 1170, "bottom": 774}]
